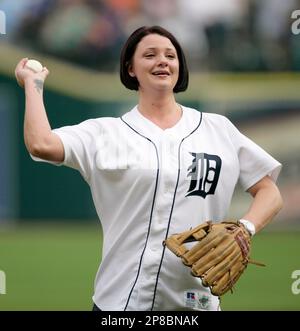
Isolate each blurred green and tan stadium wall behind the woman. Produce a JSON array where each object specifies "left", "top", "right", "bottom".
[{"left": 0, "top": 37, "right": 300, "bottom": 229}]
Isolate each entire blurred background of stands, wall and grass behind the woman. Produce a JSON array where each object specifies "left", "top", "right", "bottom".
[{"left": 0, "top": 0, "right": 300, "bottom": 310}]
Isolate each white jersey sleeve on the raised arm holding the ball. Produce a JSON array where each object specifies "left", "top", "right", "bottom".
[{"left": 32, "top": 119, "right": 102, "bottom": 182}]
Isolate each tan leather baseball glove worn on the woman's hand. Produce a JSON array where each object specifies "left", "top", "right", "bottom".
[{"left": 164, "top": 221, "right": 263, "bottom": 296}]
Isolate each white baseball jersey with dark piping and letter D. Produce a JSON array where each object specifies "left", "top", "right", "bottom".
[{"left": 32, "top": 107, "right": 281, "bottom": 311}]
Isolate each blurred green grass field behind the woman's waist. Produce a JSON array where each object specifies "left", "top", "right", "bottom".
[{"left": 0, "top": 224, "right": 300, "bottom": 310}]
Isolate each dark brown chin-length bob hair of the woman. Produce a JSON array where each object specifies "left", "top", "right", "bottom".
[{"left": 120, "top": 26, "right": 189, "bottom": 93}]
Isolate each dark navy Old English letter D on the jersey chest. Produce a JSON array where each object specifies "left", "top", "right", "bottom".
[{"left": 186, "top": 153, "right": 222, "bottom": 199}]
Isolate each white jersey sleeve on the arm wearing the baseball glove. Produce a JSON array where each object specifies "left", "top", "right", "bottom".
[{"left": 226, "top": 119, "right": 282, "bottom": 191}]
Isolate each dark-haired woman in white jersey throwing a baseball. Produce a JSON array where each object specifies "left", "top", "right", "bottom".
[{"left": 16, "top": 26, "right": 282, "bottom": 310}]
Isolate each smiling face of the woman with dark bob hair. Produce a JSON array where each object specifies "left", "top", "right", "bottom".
[{"left": 129, "top": 34, "right": 179, "bottom": 92}]
